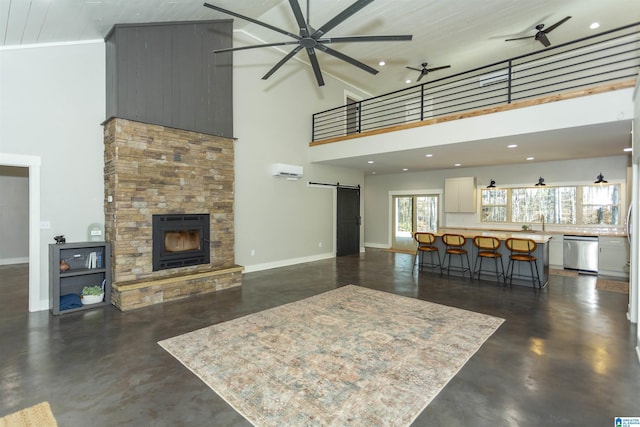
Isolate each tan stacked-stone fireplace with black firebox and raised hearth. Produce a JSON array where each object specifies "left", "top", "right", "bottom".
[{"left": 104, "top": 118, "right": 242, "bottom": 310}]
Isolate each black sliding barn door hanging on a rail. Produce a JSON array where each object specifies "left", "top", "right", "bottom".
[{"left": 336, "top": 187, "right": 360, "bottom": 256}]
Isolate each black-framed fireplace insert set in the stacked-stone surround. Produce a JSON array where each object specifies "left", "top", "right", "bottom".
[{"left": 152, "top": 214, "right": 210, "bottom": 271}]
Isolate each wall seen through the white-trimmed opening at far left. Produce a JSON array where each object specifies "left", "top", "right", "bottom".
[{"left": 0, "top": 165, "right": 29, "bottom": 265}]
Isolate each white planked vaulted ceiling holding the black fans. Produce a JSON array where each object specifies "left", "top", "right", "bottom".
[{"left": 0, "top": 0, "right": 640, "bottom": 174}]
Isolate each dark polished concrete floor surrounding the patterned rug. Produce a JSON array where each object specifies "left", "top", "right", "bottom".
[{"left": 0, "top": 250, "right": 640, "bottom": 427}]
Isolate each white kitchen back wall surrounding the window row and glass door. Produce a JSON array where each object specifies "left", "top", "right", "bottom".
[{"left": 364, "top": 155, "right": 631, "bottom": 247}]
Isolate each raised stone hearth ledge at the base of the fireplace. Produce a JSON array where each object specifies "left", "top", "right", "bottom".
[{"left": 111, "top": 265, "right": 244, "bottom": 311}]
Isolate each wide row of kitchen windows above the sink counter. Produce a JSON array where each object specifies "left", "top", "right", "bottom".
[{"left": 480, "top": 184, "right": 621, "bottom": 225}]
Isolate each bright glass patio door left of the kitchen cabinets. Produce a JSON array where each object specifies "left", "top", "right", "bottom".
[{"left": 391, "top": 194, "right": 440, "bottom": 252}]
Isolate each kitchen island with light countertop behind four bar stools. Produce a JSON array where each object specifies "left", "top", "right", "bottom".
[{"left": 434, "top": 228, "right": 553, "bottom": 287}]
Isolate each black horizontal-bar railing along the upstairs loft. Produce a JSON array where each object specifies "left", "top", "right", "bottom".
[{"left": 312, "top": 22, "right": 640, "bottom": 142}]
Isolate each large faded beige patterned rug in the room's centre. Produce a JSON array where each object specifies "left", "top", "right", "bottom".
[{"left": 159, "top": 285, "right": 504, "bottom": 426}]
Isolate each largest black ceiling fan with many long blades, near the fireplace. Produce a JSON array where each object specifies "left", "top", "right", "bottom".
[{"left": 204, "top": 0, "right": 413, "bottom": 86}]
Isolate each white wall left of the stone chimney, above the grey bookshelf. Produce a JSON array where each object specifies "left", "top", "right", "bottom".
[{"left": 0, "top": 42, "right": 105, "bottom": 309}]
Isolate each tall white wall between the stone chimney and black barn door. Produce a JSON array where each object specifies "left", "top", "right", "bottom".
[{"left": 233, "top": 35, "right": 364, "bottom": 271}]
